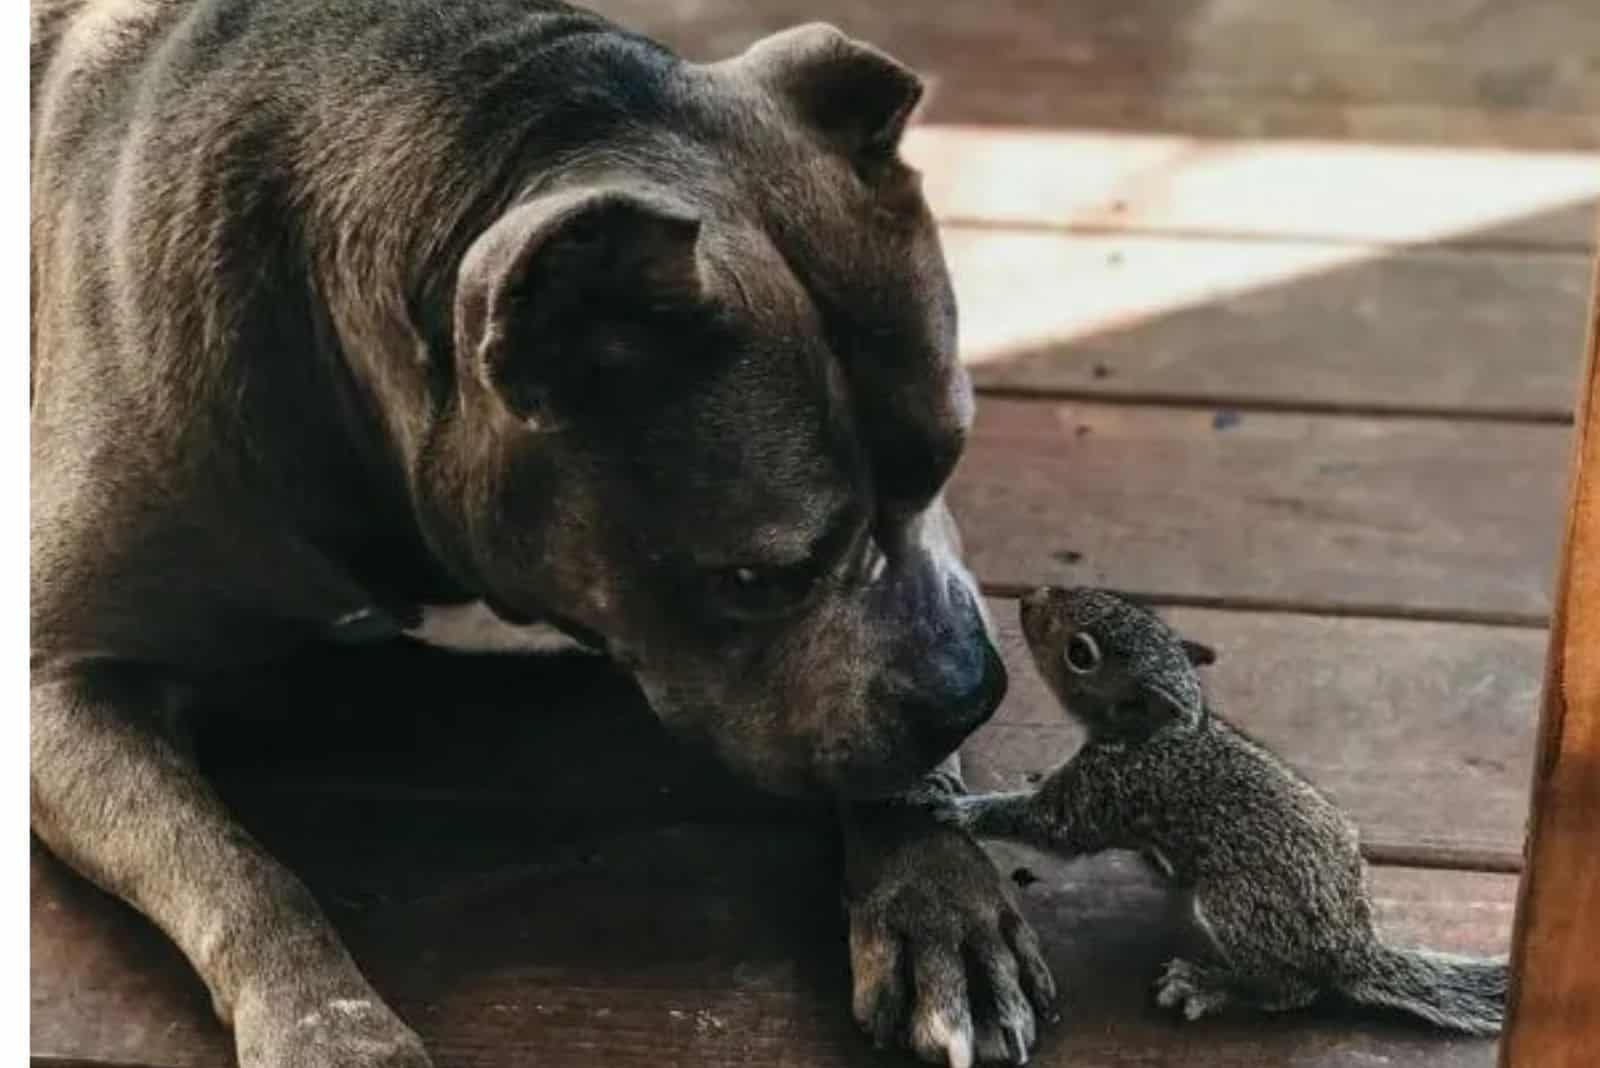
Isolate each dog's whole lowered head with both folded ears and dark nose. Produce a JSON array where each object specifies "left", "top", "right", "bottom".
[{"left": 429, "top": 26, "right": 1006, "bottom": 796}]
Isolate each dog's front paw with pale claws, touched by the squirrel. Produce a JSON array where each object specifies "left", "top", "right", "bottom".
[{"left": 843, "top": 758, "right": 1056, "bottom": 1068}]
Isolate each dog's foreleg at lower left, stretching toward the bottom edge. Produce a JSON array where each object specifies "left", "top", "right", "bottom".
[{"left": 30, "top": 665, "right": 429, "bottom": 1068}]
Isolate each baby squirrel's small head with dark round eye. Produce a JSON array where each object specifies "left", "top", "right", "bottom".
[{"left": 1021, "top": 587, "right": 1216, "bottom": 737}]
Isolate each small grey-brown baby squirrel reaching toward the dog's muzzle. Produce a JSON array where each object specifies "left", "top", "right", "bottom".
[{"left": 942, "top": 587, "right": 1506, "bottom": 1034}]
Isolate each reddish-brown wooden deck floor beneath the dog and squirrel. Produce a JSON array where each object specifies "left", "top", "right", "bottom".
[{"left": 32, "top": 0, "right": 1600, "bottom": 1068}]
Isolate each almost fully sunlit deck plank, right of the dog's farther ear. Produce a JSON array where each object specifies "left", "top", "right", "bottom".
[{"left": 904, "top": 123, "right": 1600, "bottom": 251}]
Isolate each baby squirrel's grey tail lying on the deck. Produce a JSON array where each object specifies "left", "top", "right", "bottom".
[{"left": 1341, "top": 945, "right": 1507, "bottom": 1034}]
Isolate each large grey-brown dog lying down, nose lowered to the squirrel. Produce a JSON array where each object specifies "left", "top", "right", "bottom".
[{"left": 29, "top": 0, "right": 1053, "bottom": 1068}]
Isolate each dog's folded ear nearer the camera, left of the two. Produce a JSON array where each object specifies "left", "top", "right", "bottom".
[{"left": 454, "top": 187, "right": 704, "bottom": 419}]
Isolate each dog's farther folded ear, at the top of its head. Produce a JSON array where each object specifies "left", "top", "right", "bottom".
[{"left": 738, "top": 22, "right": 923, "bottom": 163}]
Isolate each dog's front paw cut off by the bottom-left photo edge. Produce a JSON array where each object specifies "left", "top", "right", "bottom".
[{"left": 234, "top": 991, "right": 432, "bottom": 1068}]
